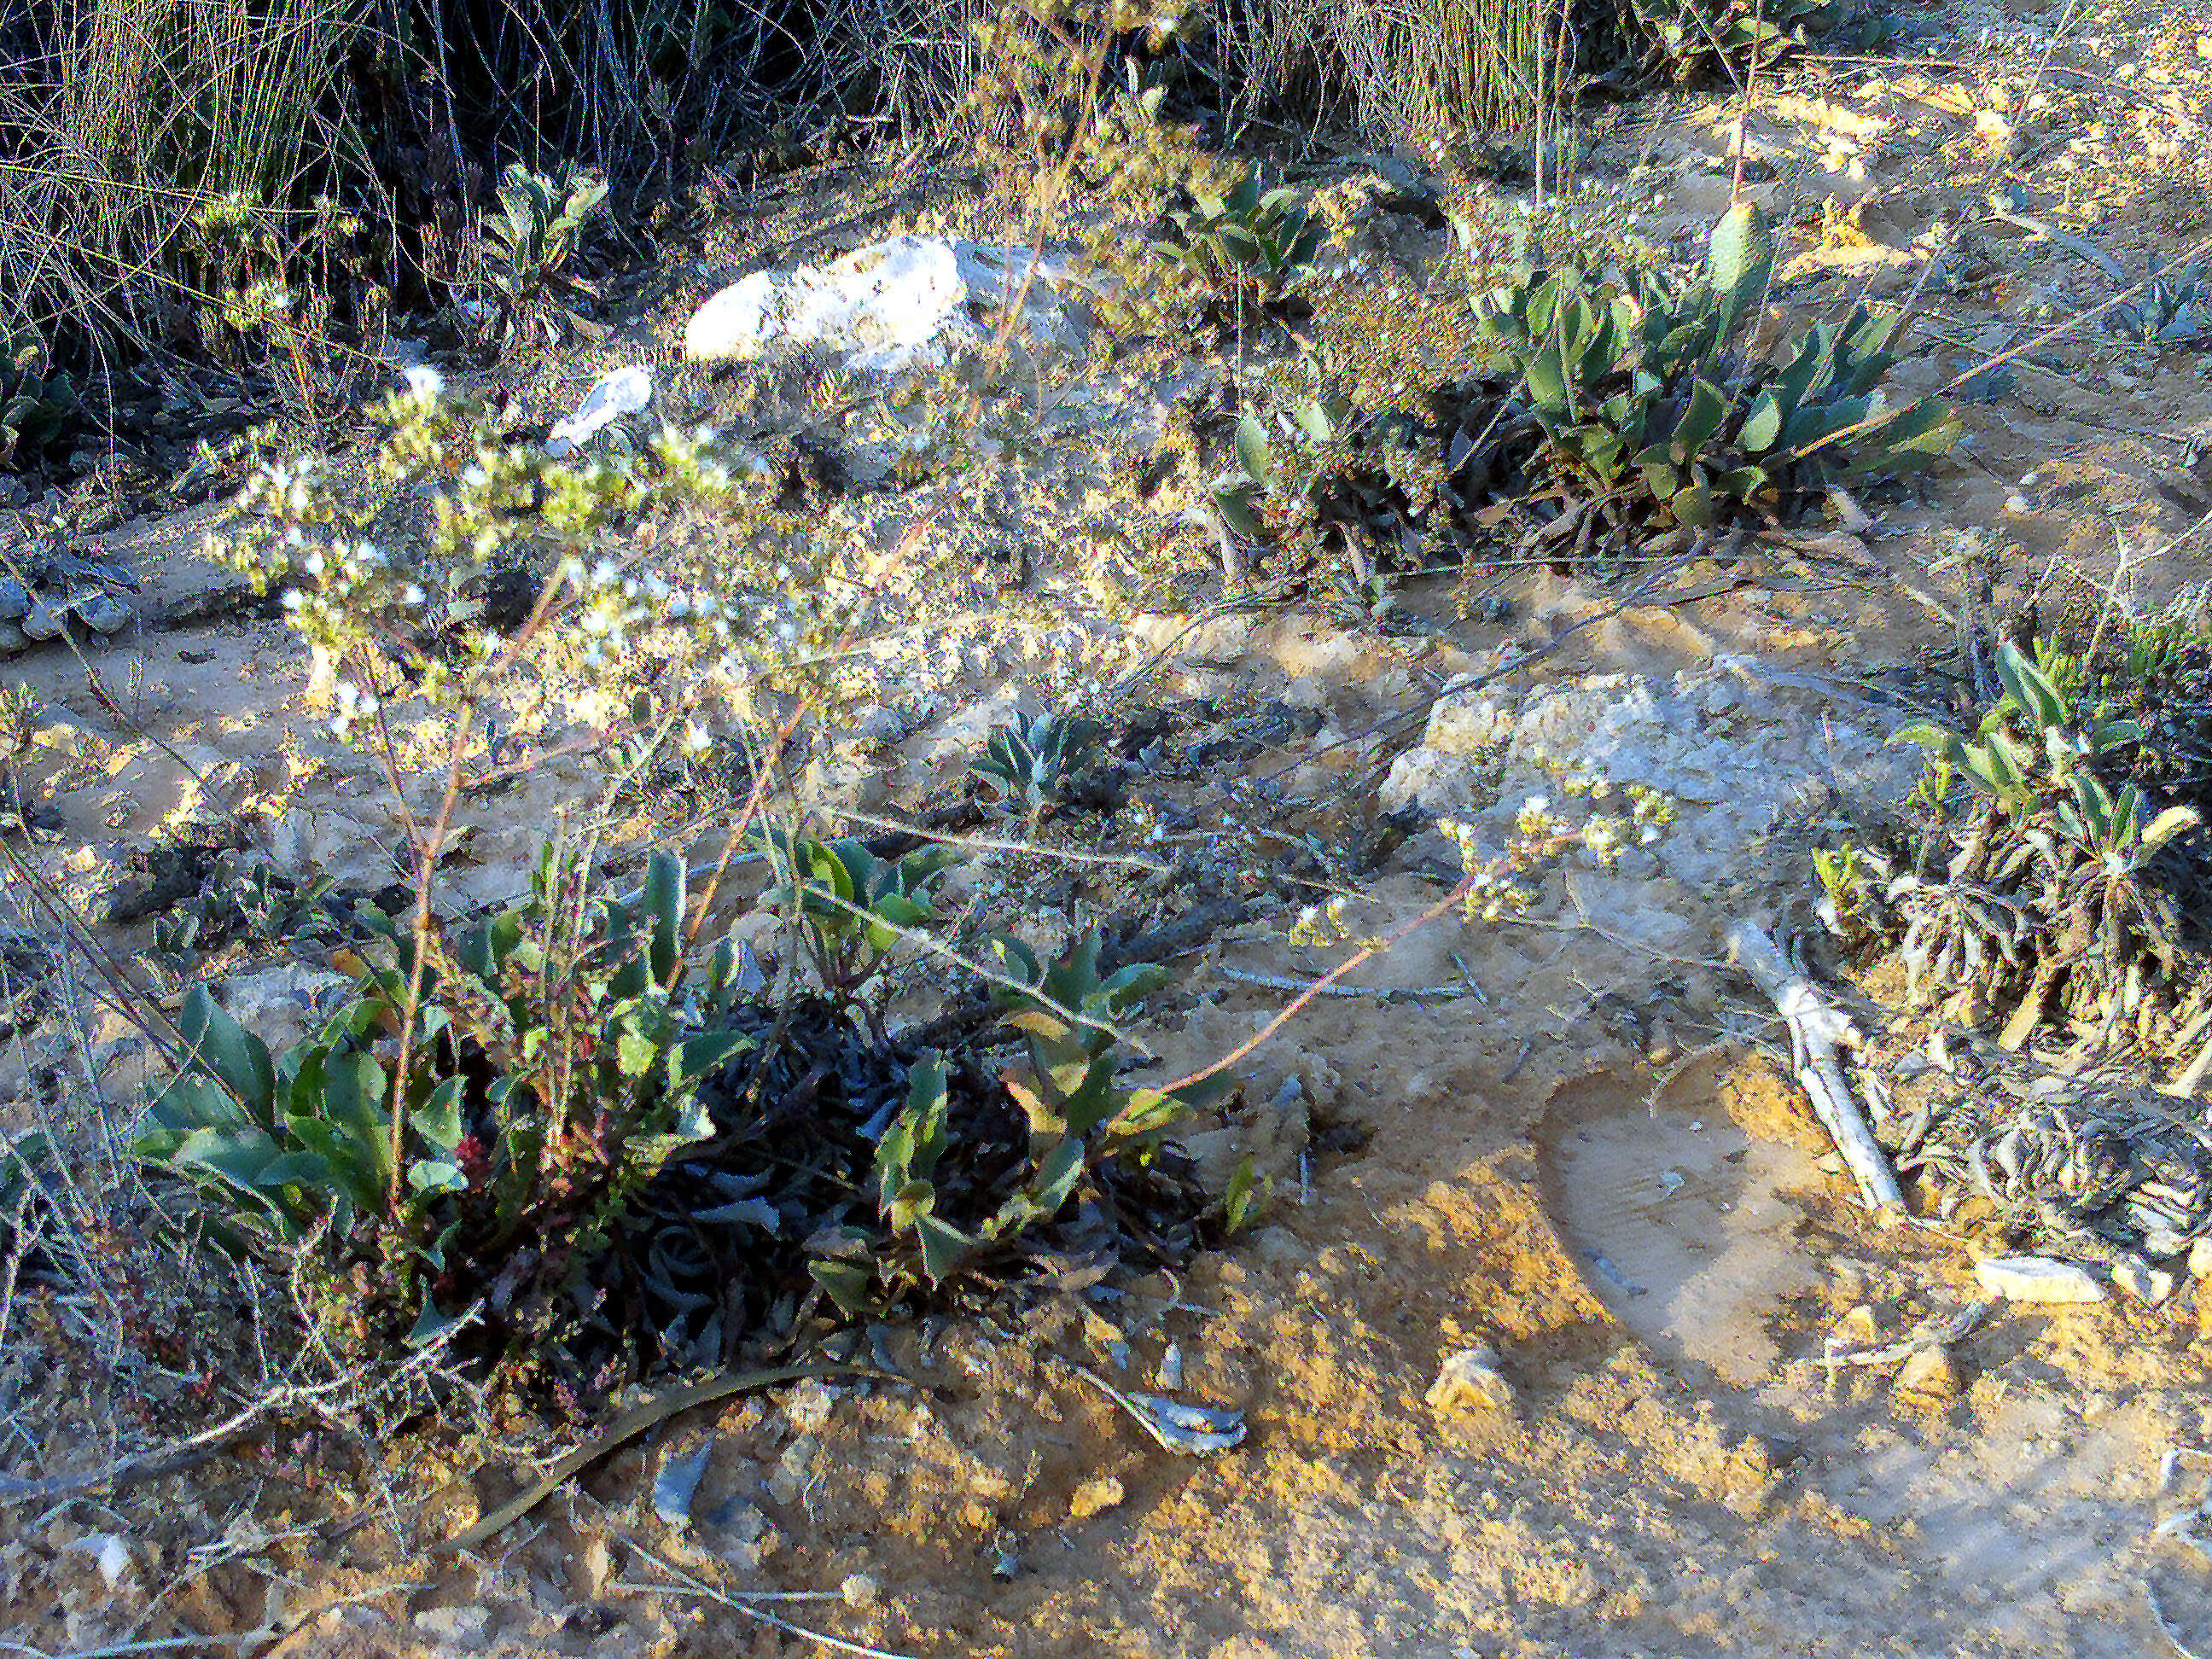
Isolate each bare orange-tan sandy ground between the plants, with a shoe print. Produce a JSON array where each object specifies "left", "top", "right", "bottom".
[{"left": 0, "top": 4, "right": 2212, "bottom": 1659}]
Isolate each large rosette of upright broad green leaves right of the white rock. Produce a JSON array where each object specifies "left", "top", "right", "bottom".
[{"left": 1449, "top": 203, "right": 1960, "bottom": 553}]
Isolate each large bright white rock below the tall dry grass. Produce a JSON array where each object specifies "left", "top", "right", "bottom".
[{"left": 684, "top": 236, "right": 1075, "bottom": 374}]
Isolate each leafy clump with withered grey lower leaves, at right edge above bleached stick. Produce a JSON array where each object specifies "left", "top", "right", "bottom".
[{"left": 1852, "top": 642, "right": 2208, "bottom": 1046}]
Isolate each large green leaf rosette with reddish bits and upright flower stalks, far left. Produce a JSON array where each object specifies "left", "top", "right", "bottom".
[{"left": 133, "top": 852, "right": 754, "bottom": 1352}]
